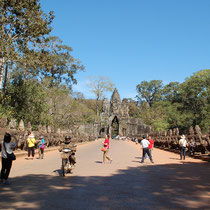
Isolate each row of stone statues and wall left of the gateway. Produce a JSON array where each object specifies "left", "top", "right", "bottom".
[{"left": 0, "top": 118, "right": 99, "bottom": 150}]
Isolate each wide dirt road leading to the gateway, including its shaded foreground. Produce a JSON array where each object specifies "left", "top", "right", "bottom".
[{"left": 0, "top": 140, "right": 210, "bottom": 210}]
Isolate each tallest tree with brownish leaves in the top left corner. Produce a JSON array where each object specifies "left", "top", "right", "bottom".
[{"left": 0, "top": 0, "right": 54, "bottom": 89}]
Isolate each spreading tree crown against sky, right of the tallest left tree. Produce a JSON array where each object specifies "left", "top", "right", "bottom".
[{"left": 36, "top": 37, "right": 84, "bottom": 88}]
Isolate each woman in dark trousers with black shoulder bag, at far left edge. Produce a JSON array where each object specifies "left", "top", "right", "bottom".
[{"left": 1, "top": 133, "right": 18, "bottom": 184}]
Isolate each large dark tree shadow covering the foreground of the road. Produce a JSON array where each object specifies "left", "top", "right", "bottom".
[{"left": 0, "top": 162, "right": 210, "bottom": 209}]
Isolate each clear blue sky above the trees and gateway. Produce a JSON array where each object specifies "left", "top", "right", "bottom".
[{"left": 41, "top": 0, "right": 210, "bottom": 99}]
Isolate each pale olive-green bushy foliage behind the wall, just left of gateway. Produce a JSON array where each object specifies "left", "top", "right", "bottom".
[{"left": 43, "top": 86, "right": 98, "bottom": 129}]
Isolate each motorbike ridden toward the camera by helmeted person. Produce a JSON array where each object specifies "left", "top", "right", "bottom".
[{"left": 61, "top": 148, "right": 76, "bottom": 176}]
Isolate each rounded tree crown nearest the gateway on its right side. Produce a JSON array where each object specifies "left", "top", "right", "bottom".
[{"left": 136, "top": 80, "right": 163, "bottom": 107}]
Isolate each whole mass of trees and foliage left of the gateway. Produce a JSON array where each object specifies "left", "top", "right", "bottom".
[{"left": 0, "top": 0, "right": 88, "bottom": 128}]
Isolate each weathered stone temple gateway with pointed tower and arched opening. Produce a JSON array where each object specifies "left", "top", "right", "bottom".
[{"left": 99, "top": 89, "right": 150, "bottom": 137}]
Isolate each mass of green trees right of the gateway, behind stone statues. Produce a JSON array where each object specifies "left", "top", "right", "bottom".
[{"left": 137, "top": 70, "right": 210, "bottom": 131}]
